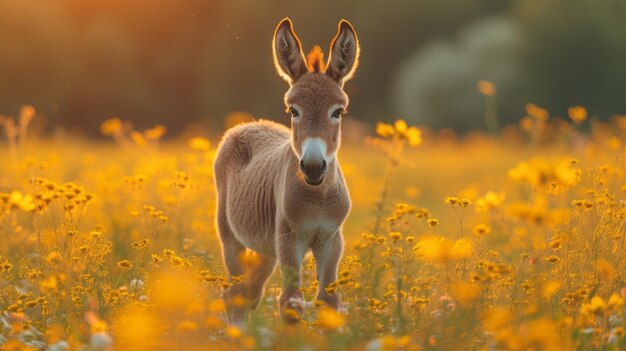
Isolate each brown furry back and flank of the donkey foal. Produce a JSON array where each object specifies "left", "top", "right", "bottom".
[{"left": 213, "top": 120, "right": 290, "bottom": 256}]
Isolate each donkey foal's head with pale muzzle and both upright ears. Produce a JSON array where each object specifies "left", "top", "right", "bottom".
[{"left": 273, "top": 18, "right": 359, "bottom": 185}]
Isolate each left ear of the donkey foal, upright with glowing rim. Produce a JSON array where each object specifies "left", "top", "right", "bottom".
[{"left": 272, "top": 18, "right": 307, "bottom": 84}]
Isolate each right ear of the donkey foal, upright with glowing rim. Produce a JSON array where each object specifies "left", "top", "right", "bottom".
[{"left": 326, "top": 19, "right": 361, "bottom": 86}]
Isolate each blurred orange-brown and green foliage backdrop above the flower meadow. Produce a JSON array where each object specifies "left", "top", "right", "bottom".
[{"left": 0, "top": 0, "right": 626, "bottom": 134}]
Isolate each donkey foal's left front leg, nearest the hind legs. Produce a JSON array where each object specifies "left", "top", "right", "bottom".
[{"left": 276, "top": 224, "right": 305, "bottom": 323}]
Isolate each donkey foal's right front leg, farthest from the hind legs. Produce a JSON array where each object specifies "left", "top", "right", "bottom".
[{"left": 312, "top": 229, "right": 343, "bottom": 308}]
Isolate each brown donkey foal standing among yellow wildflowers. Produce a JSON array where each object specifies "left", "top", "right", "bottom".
[{"left": 214, "top": 18, "right": 359, "bottom": 323}]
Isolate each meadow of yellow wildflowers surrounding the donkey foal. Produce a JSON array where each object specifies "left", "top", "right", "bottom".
[{"left": 0, "top": 104, "right": 626, "bottom": 351}]
